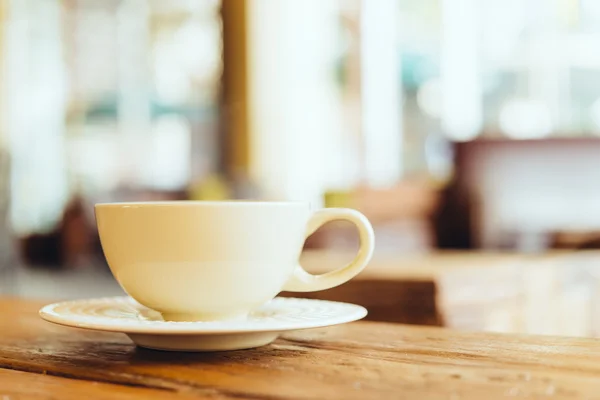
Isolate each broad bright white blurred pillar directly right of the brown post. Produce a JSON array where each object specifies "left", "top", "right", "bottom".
[{"left": 247, "top": 0, "right": 342, "bottom": 203}]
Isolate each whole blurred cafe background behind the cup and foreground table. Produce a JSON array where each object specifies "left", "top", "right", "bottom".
[{"left": 0, "top": 0, "right": 600, "bottom": 336}]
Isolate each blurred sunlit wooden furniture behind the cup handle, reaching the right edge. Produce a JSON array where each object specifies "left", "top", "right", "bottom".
[{"left": 284, "top": 250, "right": 600, "bottom": 336}]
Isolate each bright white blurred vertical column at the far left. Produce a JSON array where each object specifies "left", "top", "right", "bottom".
[{"left": 2, "top": 0, "right": 69, "bottom": 234}]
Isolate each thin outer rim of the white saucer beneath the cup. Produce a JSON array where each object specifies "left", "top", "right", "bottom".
[{"left": 38, "top": 296, "right": 368, "bottom": 335}]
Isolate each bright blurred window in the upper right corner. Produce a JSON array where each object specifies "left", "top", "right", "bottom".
[{"left": 398, "top": 0, "right": 600, "bottom": 146}]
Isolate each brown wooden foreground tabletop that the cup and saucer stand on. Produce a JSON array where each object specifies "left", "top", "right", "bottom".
[{"left": 0, "top": 299, "right": 600, "bottom": 400}]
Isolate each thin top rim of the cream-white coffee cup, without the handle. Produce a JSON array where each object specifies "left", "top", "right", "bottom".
[{"left": 94, "top": 200, "right": 310, "bottom": 208}]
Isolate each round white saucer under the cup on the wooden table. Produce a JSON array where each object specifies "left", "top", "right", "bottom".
[{"left": 40, "top": 297, "right": 367, "bottom": 351}]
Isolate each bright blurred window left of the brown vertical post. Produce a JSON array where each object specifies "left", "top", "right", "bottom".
[{"left": 1, "top": 0, "right": 222, "bottom": 234}]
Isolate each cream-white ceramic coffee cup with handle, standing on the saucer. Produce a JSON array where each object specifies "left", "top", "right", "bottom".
[{"left": 95, "top": 201, "right": 374, "bottom": 321}]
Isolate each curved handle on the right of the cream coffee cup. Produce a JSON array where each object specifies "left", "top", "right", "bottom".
[{"left": 283, "top": 208, "right": 375, "bottom": 292}]
